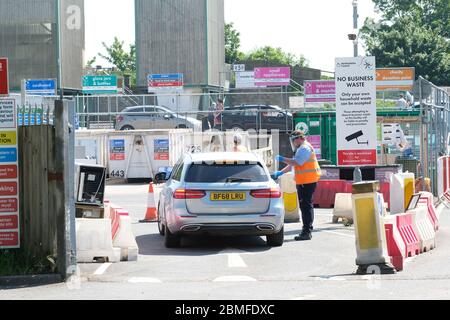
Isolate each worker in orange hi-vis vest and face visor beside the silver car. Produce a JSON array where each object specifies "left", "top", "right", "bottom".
[{"left": 275, "top": 131, "right": 321, "bottom": 241}]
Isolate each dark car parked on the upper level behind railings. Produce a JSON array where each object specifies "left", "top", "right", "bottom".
[{"left": 211, "top": 104, "right": 294, "bottom": 132}]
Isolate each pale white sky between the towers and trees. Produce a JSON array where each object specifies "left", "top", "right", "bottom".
[{"left": 85, "top": 0, "right": 375, "bottom": 71}]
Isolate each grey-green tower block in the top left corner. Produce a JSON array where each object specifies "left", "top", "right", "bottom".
[{"left": 0, "top": 0, "right": 84, "bottom": 91}]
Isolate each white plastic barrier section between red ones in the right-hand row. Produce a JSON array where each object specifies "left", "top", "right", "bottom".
[{"left": 408, "top": 207, "right": 436, "bottom": 253}]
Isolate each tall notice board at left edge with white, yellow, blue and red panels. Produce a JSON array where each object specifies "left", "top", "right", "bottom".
[{"left": 0, "top": 99, "right": 20, "bottom": 249}]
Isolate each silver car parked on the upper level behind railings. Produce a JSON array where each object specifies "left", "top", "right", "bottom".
[{"left": 115, "top": 106, "right": 202, "bottom": 131}]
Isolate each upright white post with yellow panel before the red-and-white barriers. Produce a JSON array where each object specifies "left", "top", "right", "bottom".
[{"left": 352, "top": 181, "right": 396, "bottom": 275}]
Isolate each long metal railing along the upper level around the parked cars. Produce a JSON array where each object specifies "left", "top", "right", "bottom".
[{"left": 75, "top": 91, "right": 305, "bottom": 131}]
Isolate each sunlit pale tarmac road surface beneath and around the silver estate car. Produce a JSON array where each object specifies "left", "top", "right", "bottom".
[{"left": 0, "top": 184, "right": 450, "bottom": 301}]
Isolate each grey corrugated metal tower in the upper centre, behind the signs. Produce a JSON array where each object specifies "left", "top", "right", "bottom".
[{"left": 136, "top": 0, "right": 225, "bottom": 86}]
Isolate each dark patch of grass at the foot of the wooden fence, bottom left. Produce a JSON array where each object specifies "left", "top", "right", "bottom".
[{"left": 0, "top": 250, "right": 56, "bottom": 277}]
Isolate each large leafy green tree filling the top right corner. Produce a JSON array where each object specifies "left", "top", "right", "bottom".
[{"left": 361, "top": 0, "right": 450, "bottom": 85}]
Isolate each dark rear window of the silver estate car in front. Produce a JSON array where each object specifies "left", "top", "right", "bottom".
[{"left": 185, "top": 163, "right": 269, "bottom": 183}]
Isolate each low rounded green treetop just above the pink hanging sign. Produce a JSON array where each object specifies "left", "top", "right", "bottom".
[{"left": 245, "top": 46, "right": 308, "bottom": 67}]
